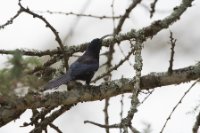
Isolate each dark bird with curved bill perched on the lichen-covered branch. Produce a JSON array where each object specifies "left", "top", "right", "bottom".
[{"left": 44, "top": 38, "right": 102, "bottom": 90}]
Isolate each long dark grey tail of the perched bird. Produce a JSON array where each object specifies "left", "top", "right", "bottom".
[{"left": 44, "top": 74, "right": 71, "bottom": 90}]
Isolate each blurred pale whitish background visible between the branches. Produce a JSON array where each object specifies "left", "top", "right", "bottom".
[{"left": 0, "top": 0, "right": 200, "bottom": 133}]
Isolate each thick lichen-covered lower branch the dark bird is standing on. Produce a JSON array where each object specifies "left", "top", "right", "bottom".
[{"left": 0, "top": 63, "right": 200, "bottom": 126}]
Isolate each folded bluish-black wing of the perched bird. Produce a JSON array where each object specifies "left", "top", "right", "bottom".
[{"left": 70, "top": 61, "right": 99, "bottom": 76}]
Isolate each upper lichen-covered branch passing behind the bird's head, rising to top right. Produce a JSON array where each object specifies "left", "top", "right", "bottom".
[{"left": 0, "top": 0, "right": 194, "bottom": 59}]
